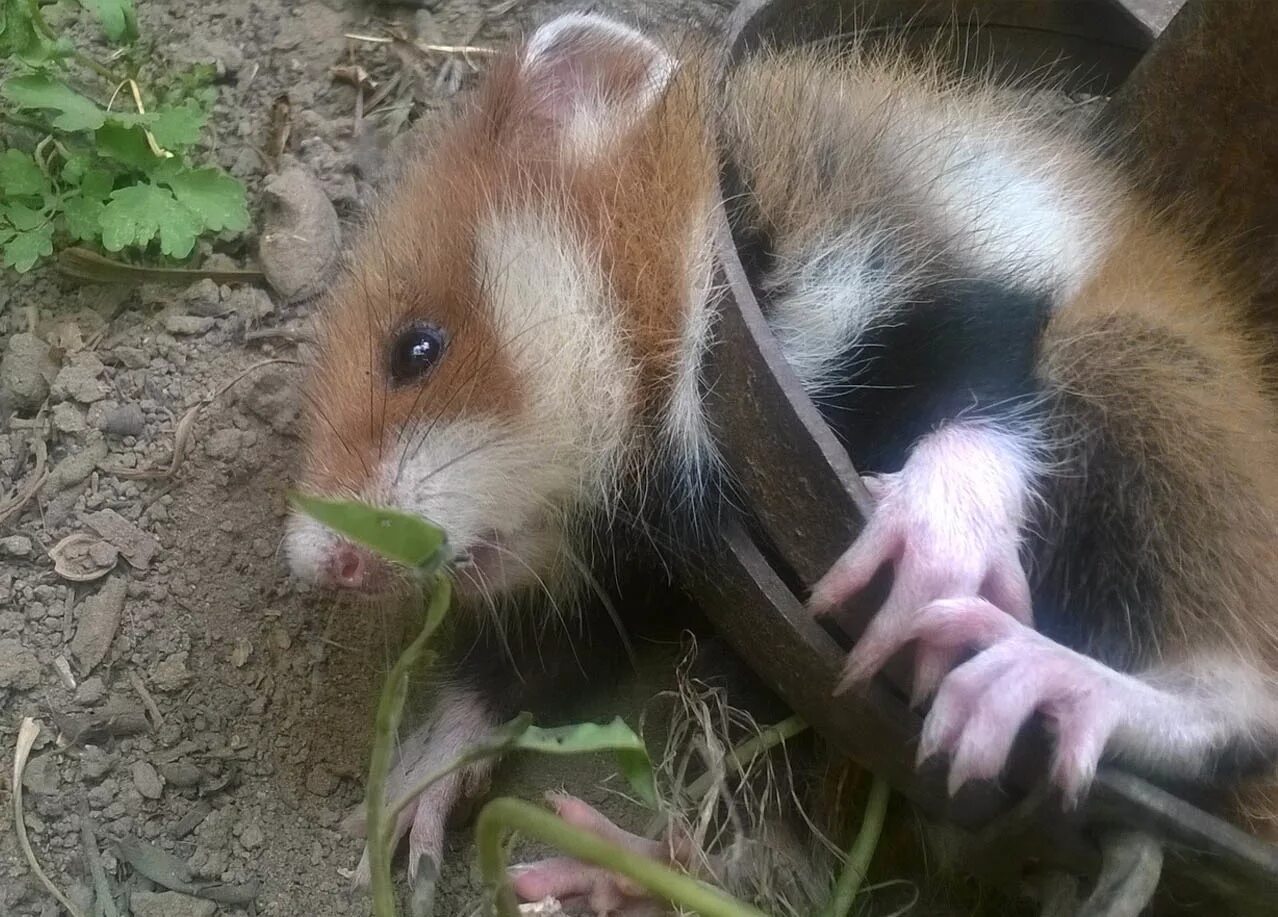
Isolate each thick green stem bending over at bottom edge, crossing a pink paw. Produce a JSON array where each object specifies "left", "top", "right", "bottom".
[{"left": 475, "top": 798, "right": 764, "bottom": 917}]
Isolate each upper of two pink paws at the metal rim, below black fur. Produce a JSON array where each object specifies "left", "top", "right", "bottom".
[{"left": 809, "top": 427, "right": 1033, "bottom": 704}]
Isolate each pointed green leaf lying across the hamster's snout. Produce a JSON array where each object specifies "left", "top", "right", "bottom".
[{"left": 289, "top": 493, "right": 447, "bottom": 572}]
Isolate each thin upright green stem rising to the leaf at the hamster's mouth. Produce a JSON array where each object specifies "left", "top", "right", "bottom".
[{"left": 367, "top": 573, "right": 452, "bottom": 917}]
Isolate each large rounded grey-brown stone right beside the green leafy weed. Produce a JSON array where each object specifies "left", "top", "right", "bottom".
[{"left": 258, "top": 166, "right": 341, "bottom": 301}]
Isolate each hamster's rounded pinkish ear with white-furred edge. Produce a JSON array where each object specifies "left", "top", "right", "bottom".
[{"left": 519, "top": 13, "right": 675, "bottom": 153}]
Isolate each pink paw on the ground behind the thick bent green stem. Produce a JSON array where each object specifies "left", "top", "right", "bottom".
[{"left": 511, "top": 793, "right": 679, "bottom": 917}]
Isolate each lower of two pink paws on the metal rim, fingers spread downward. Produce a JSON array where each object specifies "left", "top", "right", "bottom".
[{"left": 865, "top": 599, "right": 1119, "bottom": 805}]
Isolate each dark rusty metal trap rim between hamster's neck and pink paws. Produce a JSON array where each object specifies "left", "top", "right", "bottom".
[{"left": 689, "top": 0, "right": 1278, "bottom": 909}]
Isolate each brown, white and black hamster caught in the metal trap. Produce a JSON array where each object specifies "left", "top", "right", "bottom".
[{"left": 288, "top": 8, "right": 1278, "bottom": 899}]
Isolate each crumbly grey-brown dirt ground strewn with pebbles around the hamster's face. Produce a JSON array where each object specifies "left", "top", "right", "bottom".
[{"left": 0, "top": 0, "right": 728, "bottom": 917}]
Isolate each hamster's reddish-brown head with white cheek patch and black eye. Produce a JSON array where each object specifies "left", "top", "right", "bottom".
[{"left": 286, "top": 14, "right": 714, "bottom": 594}]
